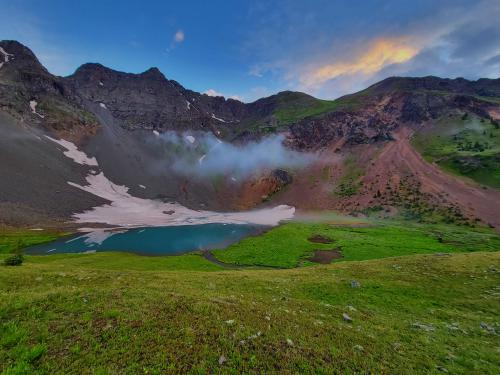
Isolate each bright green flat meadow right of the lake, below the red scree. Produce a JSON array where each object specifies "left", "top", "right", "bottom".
[{"left": 212, "top": 221, "right": 500, "bottom": 268}]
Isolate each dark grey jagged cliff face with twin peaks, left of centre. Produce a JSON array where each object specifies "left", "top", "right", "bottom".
[{"left": 65, "top": 64, "right": 245, "bottom": 132}]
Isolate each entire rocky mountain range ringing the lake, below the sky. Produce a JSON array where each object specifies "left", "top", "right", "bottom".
[{"left": 0, "top": 41, "right": 500, "bottom": 227}]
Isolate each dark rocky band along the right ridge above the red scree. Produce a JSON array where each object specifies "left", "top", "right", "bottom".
[{"left": 289, "top": 81, "right": 500, "bottom": 149}]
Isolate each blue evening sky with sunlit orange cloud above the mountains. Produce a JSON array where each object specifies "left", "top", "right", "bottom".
[{"left": 0, "top": 0, "right": 500, "bottom": 102}]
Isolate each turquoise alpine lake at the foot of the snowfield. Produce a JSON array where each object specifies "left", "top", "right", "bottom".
[{"left": 25, "top": 224, "right": 266, "bottom": 255}]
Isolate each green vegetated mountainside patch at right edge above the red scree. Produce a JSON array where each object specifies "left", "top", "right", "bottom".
[{"left": 412, "top": 115, "right": 500, "bottom": 188}]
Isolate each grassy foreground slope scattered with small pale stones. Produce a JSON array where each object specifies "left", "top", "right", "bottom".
[{"left": 0, "top": 252, "right": 500, "bottom": 374}]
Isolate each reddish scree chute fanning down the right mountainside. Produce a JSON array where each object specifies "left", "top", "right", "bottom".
[{"left": 372, "top": 128, "right": 500, "bottom": 229}]
